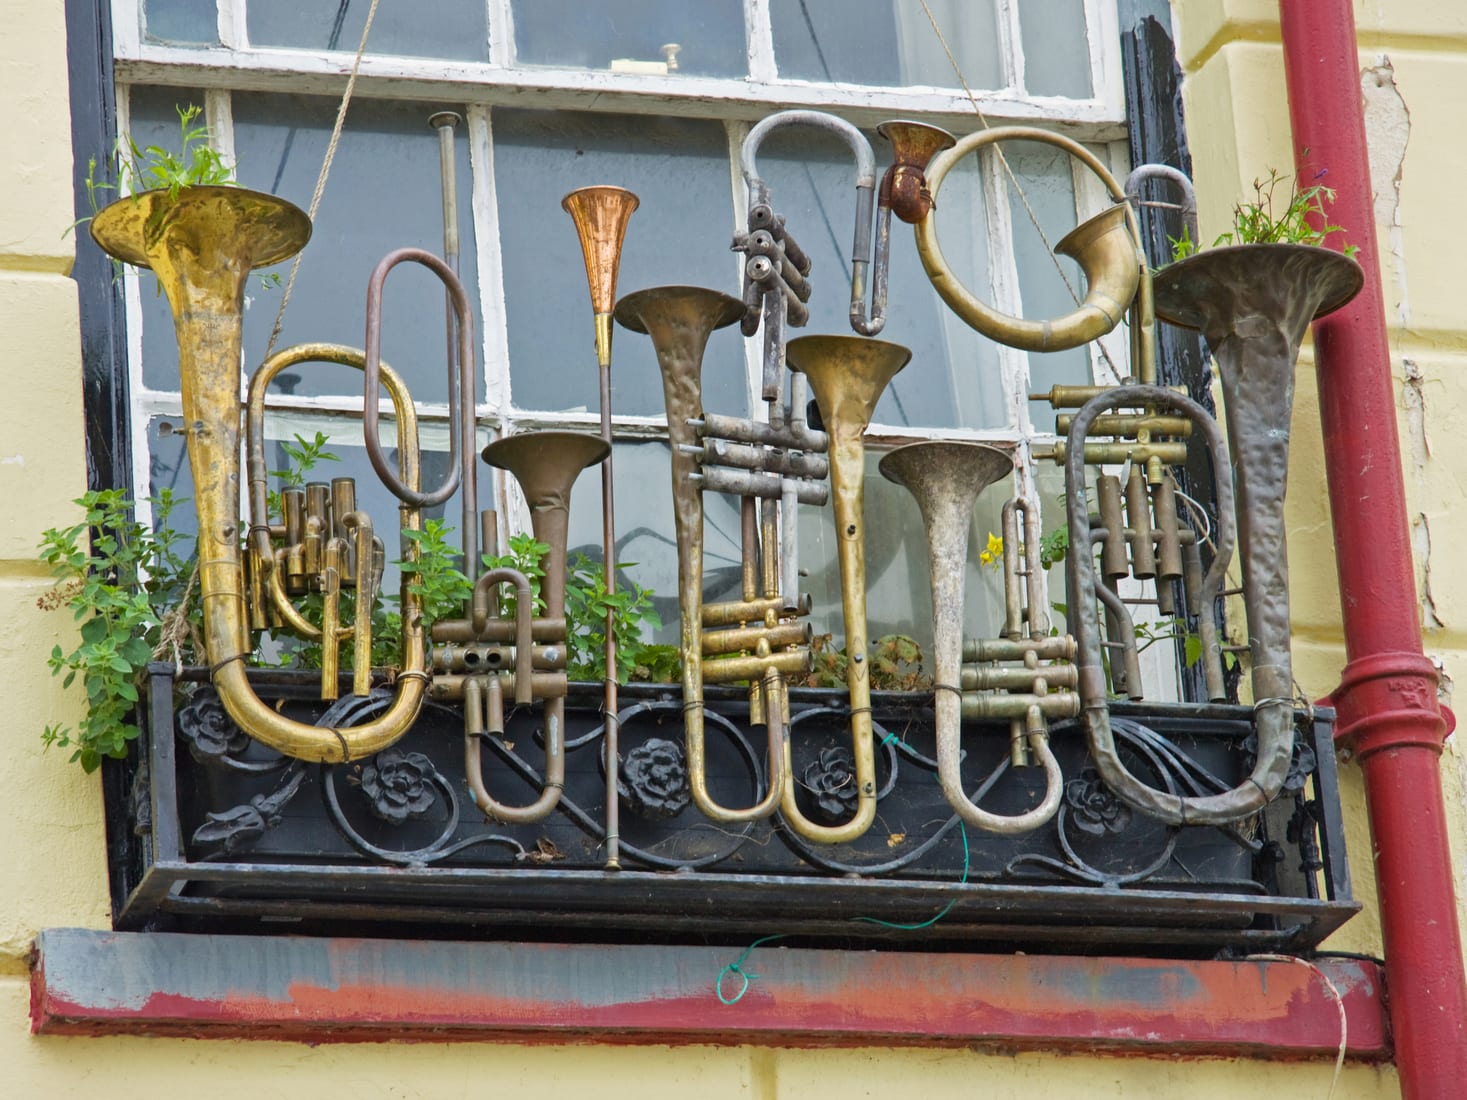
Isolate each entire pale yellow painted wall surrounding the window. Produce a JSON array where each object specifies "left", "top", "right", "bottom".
[{"left": 0, "top": 0, "right": 1443, "bottom": 1100}]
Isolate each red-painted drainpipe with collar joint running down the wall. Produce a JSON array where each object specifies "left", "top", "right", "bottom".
[{"left": 1279, "top": 0, "right": 1467, "bottom": 1100}]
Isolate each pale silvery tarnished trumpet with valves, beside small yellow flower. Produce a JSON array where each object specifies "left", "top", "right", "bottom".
[{"left": 880, "top": 441, "right": 1080, "bottom": 833}]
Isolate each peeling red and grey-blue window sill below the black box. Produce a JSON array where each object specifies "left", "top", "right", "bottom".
[{"left": 31, "top": 928, "right": 1391, "bottom": 1062}]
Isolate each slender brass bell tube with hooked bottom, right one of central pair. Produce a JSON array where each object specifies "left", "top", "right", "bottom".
[{"left": 782, "top": 336, "right": 911, "bottom": 843}]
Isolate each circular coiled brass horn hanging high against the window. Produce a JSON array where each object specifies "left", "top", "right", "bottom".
[{"left": 917, "top": 126, "right": 1146, "bottom": 352}]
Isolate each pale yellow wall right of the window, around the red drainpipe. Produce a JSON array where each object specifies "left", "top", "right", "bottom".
[{"left": 1174, "top": 0, "right": 1467, "bottom": 979}]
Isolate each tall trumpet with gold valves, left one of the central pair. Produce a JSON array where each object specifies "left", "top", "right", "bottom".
[{"left": 616, "top": 286, "right": 810, "bottom": 823}]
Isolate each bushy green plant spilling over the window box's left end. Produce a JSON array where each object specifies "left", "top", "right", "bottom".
[{"left": 37, "top": 490, "right": 202, "bottom": 771}]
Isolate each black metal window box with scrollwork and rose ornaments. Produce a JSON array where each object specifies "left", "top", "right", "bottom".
[{"left": 107, "top": 664, "right": 1360, "bottom": 956}]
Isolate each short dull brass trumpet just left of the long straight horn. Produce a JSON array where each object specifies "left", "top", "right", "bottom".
[{"left": 448, "top": 431, "right": 609, "bottom": 824}]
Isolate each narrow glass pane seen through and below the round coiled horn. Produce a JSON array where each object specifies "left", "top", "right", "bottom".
[{"left": 999, "top": 142, "right": 1103, "bottom": 431}]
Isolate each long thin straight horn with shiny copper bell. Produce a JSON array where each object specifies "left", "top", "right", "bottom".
[{"left": 560, "top": 186, "right": 641, "bottom": 870}]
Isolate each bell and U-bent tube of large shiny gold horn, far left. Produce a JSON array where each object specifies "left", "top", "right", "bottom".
[{"left": 91, "top": 186, "right": 427, "bottom": 764}]
